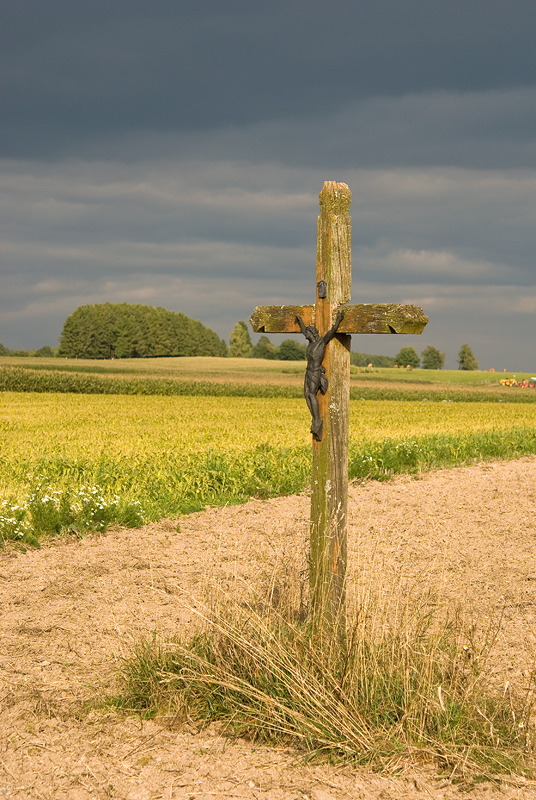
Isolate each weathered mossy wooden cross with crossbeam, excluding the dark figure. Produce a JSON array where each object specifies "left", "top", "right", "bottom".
[{"left": 250, "top": 181, "right": 428, "bottom": 633}]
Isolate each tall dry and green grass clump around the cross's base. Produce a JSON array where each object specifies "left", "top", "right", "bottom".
[{"left": 119, "top": 580, "right": 533, "bottom": 779}]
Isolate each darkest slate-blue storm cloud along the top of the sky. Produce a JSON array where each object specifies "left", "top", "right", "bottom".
[{"left": 2, "top": 0, "right": 536, "bottom": 158}]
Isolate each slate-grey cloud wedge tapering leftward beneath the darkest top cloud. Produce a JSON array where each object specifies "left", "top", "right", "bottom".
[{"left": 152, "top": 88, "right": 536, "bottom": 170}]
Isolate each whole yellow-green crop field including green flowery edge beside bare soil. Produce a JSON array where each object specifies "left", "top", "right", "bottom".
[{"left": 0, "top": 392, "right": 536, "bottom": 538}]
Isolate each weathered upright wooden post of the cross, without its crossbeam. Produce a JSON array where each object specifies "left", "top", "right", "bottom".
[{"left": 309, "top": 182, "right": 352, "bottom": 631}]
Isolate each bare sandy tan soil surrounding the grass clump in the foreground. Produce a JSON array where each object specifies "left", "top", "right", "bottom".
[{"left": 0, "top": 457, "right": 536, "bottom": 800}]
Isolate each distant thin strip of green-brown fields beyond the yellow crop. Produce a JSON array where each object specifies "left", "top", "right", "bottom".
[{"left": 0, "top": 357, "right": 536, "bottom": 403}]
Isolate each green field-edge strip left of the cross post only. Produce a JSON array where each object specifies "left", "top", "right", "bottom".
[{"left": 0, "top": 445, "right": 310, "bottom": 531}]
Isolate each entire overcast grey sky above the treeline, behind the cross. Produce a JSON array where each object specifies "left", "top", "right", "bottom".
[{"left": 0, "top": 0, "right": 536, "bottom": 371}]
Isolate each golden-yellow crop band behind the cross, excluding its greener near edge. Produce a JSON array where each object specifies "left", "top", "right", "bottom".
[{"left": 0, "top": 392, "right": 536, "bottom": 460}]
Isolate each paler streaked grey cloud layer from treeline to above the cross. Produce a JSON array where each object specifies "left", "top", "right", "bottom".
[{"left": 0, "top": 161, "right": 536, "bottom": 366}]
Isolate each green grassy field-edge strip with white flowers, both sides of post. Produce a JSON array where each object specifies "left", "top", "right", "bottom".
[{"left": 0, "top": 427, "right": 536, "bottom": 540}]
